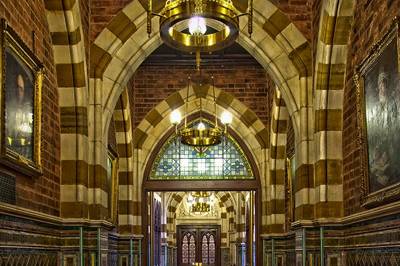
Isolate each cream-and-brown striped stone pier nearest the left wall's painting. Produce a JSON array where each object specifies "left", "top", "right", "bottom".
[{"left": 45, "top": 0, "right": 89, "bottom": 218}]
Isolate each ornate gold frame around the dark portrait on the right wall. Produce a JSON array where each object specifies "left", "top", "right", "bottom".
[{"left": 354, "top": 17, "right": 400, "bottom": 207}]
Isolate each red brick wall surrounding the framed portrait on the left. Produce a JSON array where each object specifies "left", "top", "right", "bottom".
[{"left": 0, "top": 0, "right": 60, "bottom": 215}]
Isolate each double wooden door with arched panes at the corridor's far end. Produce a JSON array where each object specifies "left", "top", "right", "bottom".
[{"left": 177, "top": 225, "right": 221, "bottom": 266}]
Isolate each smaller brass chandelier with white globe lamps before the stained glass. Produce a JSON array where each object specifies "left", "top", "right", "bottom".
[{"left": 170, "top": 77, "right": 232, "bottom": 154}]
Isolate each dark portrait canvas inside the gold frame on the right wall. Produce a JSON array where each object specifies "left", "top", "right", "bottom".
[{"left": 364, "top": 38, "right": 400, "bottom": 193}]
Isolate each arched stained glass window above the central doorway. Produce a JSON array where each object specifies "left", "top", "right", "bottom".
[{"left": 150, "top": 121, "right": 253, "bottom": 179}]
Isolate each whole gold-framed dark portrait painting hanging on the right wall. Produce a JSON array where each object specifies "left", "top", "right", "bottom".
[{"left": 355, "top": 19, "right": 400, "bottom": 207}]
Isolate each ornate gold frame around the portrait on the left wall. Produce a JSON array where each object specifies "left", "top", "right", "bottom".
[{"left": 0, "top": 19, "right": 44, "bottom": 176}]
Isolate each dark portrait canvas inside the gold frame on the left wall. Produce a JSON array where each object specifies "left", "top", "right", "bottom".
[{"left": 4, "top": 48, "right": 35, "bottom": 160}]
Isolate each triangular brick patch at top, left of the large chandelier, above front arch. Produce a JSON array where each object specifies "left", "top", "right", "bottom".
[{"left": 90, "top": 0, "right": 130, "bottom": 42}]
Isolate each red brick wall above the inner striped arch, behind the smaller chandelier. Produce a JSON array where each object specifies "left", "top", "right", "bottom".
[{"left": 129, "top": 53, "right": 275, "bottom": 132}]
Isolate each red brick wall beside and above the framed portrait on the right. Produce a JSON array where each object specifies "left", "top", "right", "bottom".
[{"left": 343, "top": 0, "right": 400, "bottom": 215}]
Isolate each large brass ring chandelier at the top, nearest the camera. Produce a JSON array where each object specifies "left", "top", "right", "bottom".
[{"left": 147, "top": 0, "right": 253, "bottom": 68}]
